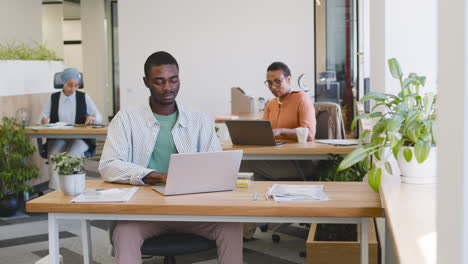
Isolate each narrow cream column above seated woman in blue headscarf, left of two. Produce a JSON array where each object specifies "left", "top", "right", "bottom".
[{"left": 42, "top": 2, "right": 63, "bottom": 58}]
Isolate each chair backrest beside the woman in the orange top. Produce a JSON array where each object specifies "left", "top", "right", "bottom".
[{"left": 314, "top": 102, "right": 346, "bottom": 139}]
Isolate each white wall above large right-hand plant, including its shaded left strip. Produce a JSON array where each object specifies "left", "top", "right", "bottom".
[{"left": 370, "top": 0, "right": 437, "bottom": 94}]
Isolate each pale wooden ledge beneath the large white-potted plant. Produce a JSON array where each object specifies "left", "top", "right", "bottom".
[{"left": 380, "top": 176, "right": 437, "bottom": 264}]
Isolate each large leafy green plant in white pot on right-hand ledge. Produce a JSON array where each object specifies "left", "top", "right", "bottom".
[{"left": 338, "top": 58, "right": 437, "bottom": 192}]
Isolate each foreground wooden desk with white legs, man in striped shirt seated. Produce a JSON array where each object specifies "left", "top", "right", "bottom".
[{"left": 26, "top": 181, "right": 382, "bottom": 264}]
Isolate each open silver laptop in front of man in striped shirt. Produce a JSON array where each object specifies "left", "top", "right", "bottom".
[{"left": 153, "top": 150, "right": 242, "bottom": 195}]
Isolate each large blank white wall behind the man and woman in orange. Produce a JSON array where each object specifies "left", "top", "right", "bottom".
[{"left": 119, "top": 0, "right": 314, "bottom": 115}]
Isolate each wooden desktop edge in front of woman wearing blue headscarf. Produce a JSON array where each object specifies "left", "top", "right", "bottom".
[{"left": 24, "top": 125, "right": 108, "bottom": 138}]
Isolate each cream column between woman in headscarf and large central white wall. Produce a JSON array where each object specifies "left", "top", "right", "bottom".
[{"left": 81, "top": 0, "right": 112, "bottom": 122}]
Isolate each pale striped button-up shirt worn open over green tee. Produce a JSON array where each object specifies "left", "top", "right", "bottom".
[{"left": 99, "top": 101, "right": 222, "bottom": 185}]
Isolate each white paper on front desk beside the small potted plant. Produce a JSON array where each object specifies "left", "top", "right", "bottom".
[{"left": 71, "top": 187, "right": 138, "bottom": 203}]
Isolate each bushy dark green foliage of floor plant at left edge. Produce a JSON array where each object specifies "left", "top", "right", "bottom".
[{"left": 0, "top": 117, "right": 40, "bottom": 217}]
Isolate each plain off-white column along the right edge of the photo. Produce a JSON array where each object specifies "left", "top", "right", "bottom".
[{"left": 437, "top": 0, "right": 468, "bottom": 264}]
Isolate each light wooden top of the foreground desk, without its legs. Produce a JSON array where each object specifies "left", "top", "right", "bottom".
[{"left": 26, "top": 180, "right": 382, "bottom": 217}]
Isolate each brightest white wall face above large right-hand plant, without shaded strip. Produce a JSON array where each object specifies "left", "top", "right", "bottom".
[{"left": 385, "top": 0, "right": 437, "bottom": 93}]
